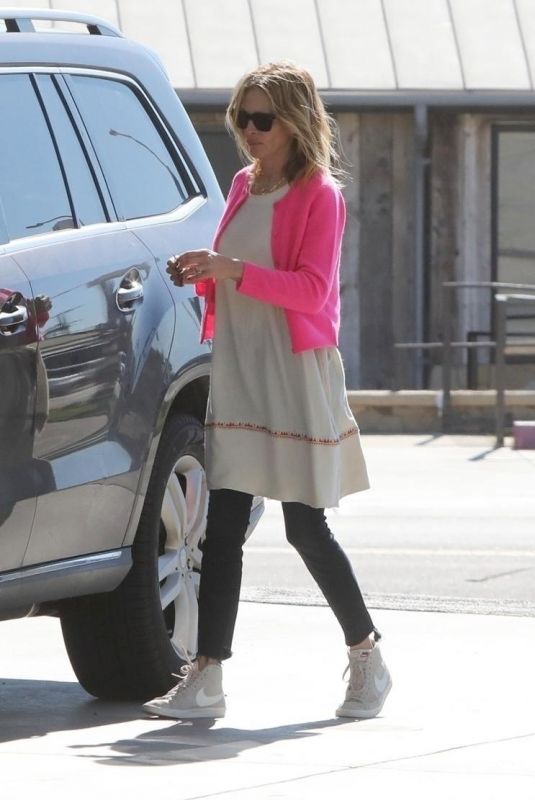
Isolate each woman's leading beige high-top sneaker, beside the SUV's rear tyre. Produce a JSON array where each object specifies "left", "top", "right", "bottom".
[{"left": 143, "top": 663, "right": 226, "bottom": 719}]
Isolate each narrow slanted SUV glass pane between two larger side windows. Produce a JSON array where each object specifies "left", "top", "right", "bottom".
[{"left": 35, "top": 75, "right": 107, "bottom": 226}]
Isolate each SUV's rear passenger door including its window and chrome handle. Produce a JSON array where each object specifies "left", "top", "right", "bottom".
[{"left": 0, "top": 74, "right": 174, "bottom": 566}]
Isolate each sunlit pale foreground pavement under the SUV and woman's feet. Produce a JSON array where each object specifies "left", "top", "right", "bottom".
[{"left": 0, "top": 602, "right": 535, "bottom": 800}]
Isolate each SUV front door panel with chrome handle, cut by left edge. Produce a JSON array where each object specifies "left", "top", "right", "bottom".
[{"left": 0, "top": 255, "right": 38, "bottom": 572}]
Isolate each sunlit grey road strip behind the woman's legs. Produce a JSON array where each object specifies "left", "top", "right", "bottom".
[{"left": 243, "top": 435, "right": 535, "bottom": 616}]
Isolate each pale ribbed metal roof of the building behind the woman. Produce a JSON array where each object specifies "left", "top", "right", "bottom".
[{"left": 9, "top": 0, "right": 535, "bottom": 115}]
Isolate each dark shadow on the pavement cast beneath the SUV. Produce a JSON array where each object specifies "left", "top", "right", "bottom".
[{"left": 0, "top": 677, "right": 143, "bottom": 744}]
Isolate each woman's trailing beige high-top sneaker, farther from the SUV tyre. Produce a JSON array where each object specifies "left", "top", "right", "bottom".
[{"left": 336, "top": 644, "right": 392, "bottom": 719}]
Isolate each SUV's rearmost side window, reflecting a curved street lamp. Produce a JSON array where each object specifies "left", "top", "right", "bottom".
[{"left": 69, "top": 75, "right": 191, "bottom": 219}]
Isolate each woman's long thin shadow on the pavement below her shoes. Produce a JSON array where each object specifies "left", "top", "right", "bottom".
[{"left": 72, "top": 719, "right": 356, "bottom": 767}]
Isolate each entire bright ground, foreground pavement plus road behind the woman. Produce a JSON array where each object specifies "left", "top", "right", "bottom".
[{"left": 0, "top": 436, "right": 535, "bottom": 800}]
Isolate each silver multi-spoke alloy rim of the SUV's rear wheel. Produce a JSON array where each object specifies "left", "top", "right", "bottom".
[{"left": 158, "top": 455, "right": 208, "bottom": 659}]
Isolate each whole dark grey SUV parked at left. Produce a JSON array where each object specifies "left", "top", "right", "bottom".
[{"left": 0, "top": 9, "right": 262, "bottom": 699}]
